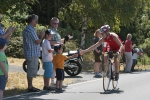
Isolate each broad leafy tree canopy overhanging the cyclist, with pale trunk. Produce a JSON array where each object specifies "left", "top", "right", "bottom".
[{"left": 59, "top": 0, "right": 142, "bottom": 47}]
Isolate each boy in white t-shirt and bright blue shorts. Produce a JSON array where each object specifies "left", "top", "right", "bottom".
[{"left": 42, "top": 29, "right": 54, "bottom": 90}]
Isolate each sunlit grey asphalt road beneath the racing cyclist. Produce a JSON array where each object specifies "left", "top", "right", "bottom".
[{"left": 4, "top": 70, "right": 150, "bottom": 100}]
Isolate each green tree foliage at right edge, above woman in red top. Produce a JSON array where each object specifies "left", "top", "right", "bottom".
[{"left": 120, "top": 0, "right": 150, "bottom": 45}]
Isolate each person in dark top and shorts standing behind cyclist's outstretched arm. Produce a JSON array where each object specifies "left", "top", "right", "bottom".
[{"left": 93, "top": 29, "right": 102, "bottom": 77}]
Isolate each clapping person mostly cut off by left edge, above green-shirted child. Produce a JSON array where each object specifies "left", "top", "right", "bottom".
[{"left": 0, "top": 13, "right": 15, "bottom": 40}]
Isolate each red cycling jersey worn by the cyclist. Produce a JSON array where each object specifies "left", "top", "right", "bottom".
[{"left": 105, "top": 33, "right": 122, "bottom": 52}]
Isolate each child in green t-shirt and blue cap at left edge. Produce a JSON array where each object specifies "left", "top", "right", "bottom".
[{"left": 0, "top": 38, "right": 8, "bottom": 100}]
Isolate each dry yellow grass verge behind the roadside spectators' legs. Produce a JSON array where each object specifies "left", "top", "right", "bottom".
[{"left": 4, "top": 72, "right": 75, "bottom": 96}]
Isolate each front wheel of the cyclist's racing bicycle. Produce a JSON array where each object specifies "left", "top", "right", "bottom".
[{"left": 103, "top": 64, "right": 111, "bottom": 91}]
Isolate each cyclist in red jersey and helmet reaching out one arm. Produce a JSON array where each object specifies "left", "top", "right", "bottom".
[{"left": 80, "top": 25, "right": 123, "bottom": 80}]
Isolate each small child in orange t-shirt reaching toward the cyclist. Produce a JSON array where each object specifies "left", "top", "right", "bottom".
[{"left": 53, "top": 44, "right": 78, "bottom": 92}]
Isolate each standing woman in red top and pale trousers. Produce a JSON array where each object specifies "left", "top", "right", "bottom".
[{"left": 124, "top": 34, "right": 132, "bottom": 73}]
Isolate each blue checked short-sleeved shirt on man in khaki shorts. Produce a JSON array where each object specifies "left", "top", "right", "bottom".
[{"left": 22, "top": 25, "right": 41, "bottom": 60}]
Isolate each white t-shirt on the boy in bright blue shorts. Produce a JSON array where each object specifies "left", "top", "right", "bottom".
[{"left": 42, "top": 39, "right": 53, "bottom": 62}]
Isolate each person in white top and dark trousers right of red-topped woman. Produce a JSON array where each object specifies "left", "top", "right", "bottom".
[{"left": 131, "top": 44, "right": 143, "bottom": 72}]
